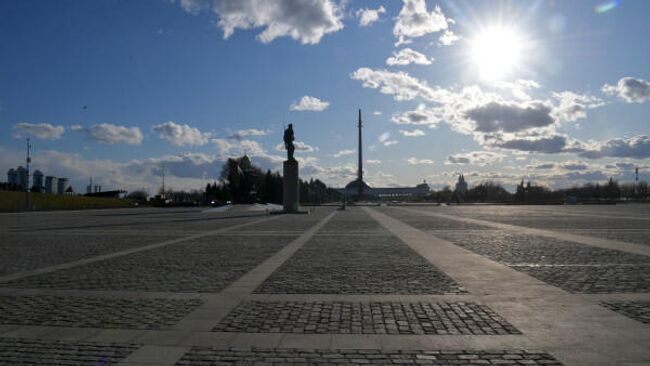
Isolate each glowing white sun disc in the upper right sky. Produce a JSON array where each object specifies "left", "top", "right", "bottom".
[{"left": 470, "top": 26, "right": 524, "bottom": 81}]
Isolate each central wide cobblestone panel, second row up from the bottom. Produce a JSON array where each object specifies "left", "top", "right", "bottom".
[{"left": 214, "top": 301, "right": 519, "bottom": 335}]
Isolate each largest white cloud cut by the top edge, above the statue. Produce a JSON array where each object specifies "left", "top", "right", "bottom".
[{"left": 180, "top": 0, "right": 343, "bottom": 44}]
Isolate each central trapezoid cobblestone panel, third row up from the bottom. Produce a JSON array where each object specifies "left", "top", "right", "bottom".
[{"left": 255, "top": 236, "right": 465, "bottom": 294}]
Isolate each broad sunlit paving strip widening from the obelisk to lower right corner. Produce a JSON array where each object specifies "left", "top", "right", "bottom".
[{"left": 364, "top": 208, "right": 650, "bottom": 366}]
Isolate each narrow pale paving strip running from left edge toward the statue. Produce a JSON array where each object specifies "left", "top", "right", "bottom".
[{"left": 0, "top": 215, "right": 280, "bottom": 286}]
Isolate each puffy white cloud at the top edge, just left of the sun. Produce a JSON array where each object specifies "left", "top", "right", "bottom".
[{"left": 393, "top": 0, "right": 453, "bottom": 46}]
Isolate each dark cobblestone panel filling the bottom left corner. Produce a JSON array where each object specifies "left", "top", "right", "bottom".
[{"left": 0, "top": 338, "right": 140, "bottom": 366}]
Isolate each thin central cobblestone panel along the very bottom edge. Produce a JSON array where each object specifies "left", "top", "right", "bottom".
[{"left": 177, "top": 347, "right": 561, "bottom": 366}]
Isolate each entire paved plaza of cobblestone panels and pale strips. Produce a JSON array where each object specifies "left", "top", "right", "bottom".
[{"left": 0, "top": 205, "right": 650, "bottom": 366}]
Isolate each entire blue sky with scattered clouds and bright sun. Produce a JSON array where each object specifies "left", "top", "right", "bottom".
[{"left": 0, "top": 0, "right": 650, "bottom": 193}]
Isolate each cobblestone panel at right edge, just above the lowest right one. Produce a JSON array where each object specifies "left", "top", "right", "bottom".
[{"left": 513, "top": 265, "right": 650, "bottom": 294}]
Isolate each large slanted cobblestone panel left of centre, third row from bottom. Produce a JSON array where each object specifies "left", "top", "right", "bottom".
[{"left": 6, "top": 235, "right": 294, "bottom": 292}]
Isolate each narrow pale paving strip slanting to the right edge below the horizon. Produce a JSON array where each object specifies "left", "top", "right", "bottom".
[{"left": 397, "top": 207, "right": 650, "bottom": 256}]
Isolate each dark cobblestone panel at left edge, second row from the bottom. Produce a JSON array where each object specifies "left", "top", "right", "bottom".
[{"left": 0, "top": 295, "right": 203, "bottom": 329}]
